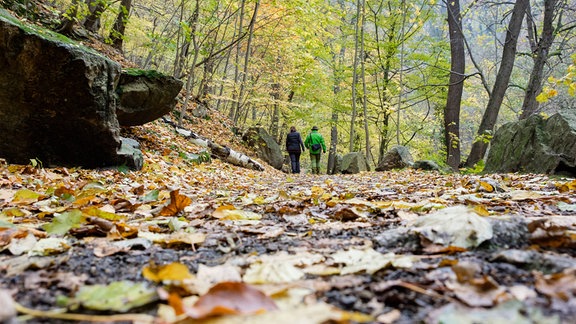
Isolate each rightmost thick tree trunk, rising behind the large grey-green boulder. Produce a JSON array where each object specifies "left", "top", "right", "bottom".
[{"left": 520, "top": 0, "right": 558, "bottom": 119}]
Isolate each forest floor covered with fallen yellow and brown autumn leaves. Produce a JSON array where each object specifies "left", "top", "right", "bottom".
[{"left": 0, "top": 112, "right": 576, "bottom": 323}]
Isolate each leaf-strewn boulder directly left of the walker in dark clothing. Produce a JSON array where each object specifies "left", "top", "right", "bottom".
[{"left": 242, "top": 127, "right": 284, "bottom": 170}]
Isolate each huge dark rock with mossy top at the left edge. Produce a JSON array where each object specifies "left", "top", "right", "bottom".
[{"left": 0, "top": 9, "right": 141, "bottom": 167}]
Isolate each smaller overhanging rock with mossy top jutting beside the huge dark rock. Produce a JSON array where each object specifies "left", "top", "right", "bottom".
[{"left": 116, "top": 69, "right": 183, "bottom": 126}]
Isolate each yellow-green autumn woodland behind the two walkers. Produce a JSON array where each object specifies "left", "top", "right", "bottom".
[{"left": 4, "top": 0, "right": 576, "bottom": 172}]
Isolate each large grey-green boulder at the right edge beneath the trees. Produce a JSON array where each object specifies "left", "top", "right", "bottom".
[{"left": 484, "top": 110, "right": 576, "bottom": 175}]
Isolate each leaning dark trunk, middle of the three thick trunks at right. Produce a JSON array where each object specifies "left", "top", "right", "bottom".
[{"left": 466, "top": 0, "right": 529, "bottom": 167}]
